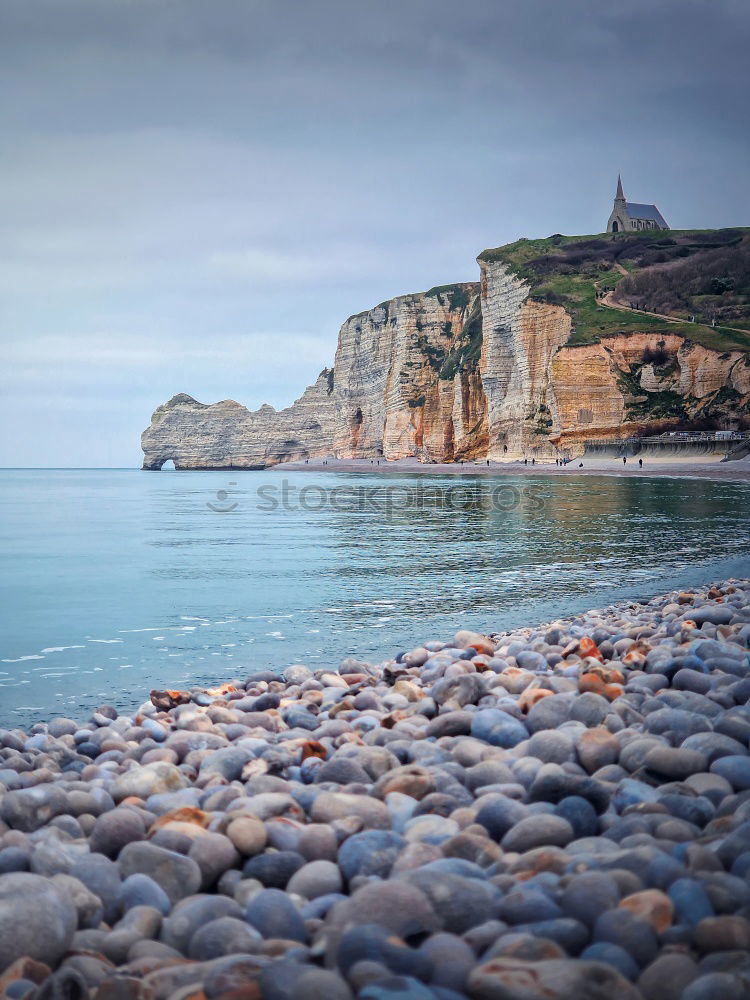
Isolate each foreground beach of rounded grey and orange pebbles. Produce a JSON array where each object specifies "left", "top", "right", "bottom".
[{"left": 0, "top": 579, "right": 750, "bottom": 1000}]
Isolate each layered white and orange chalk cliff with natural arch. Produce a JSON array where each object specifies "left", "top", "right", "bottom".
[{"left": 141, "top": 230, "right": 750, "bottom": 469}]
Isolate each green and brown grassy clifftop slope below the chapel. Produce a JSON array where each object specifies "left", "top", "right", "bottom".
[{"left": 479, "top": 228, "right": 750, "bottom": 351}]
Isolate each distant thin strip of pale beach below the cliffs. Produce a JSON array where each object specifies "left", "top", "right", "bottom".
[{"left": 274, "top": 457, "right": 750, "bottom": 482}]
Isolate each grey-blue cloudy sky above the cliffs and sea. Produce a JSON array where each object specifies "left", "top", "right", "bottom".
[{"left": 0, "top": 0, "right": 750, "bottom": 466}]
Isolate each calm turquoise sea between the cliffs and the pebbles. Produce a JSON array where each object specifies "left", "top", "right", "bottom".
[{"left": 0, "top": 469, "right": 750, "bottom": 727}]
